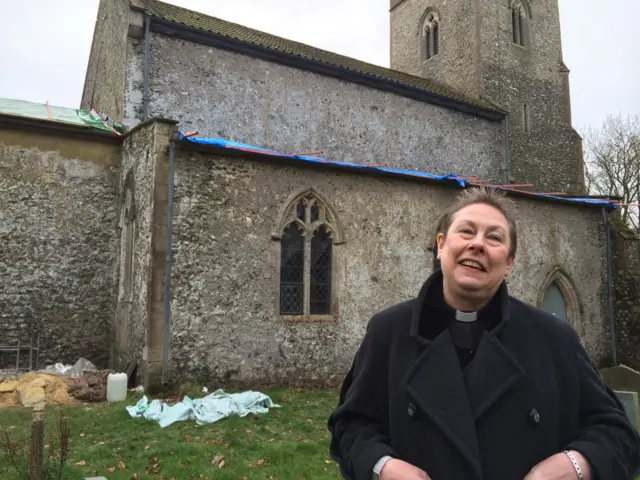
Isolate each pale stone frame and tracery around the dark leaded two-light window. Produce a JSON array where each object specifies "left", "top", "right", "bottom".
[{"left": 271, "top": 187, "right": 345, "bottom": 323}]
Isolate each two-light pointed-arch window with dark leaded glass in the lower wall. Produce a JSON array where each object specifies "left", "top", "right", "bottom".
[{"left": 275, "top": 188, "right": 343, "bottom": 316}]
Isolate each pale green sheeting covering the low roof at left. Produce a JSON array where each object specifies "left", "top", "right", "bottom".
[{"left": 0, "top": 98, "right": 124, "bottom": 133}]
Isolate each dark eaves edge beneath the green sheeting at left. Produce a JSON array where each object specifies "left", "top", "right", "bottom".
[{"left": 0, "top": 113, "right": 124, "bottom": 145}]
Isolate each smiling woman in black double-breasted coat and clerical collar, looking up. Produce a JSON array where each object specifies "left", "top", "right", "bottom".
[{"left": 329, "top": 189, "right": 640, "bottom": 480}]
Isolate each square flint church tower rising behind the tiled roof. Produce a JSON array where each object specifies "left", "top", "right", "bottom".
[{"left": 391, "top": 0, "right": 584, "bottom": 194}]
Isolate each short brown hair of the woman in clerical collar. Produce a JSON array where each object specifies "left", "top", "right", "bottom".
[{"left": 436, "top": 187, "right": 518, "bottom": 256}]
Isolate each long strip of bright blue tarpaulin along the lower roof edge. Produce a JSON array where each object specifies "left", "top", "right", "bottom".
[{"left": 180, "top": 134, "right": 617, "bottom": 208}]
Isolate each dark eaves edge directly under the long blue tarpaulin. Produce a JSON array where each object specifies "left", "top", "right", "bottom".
[{"left": 175, "top": 139, "right": 616, "bottom": 210}]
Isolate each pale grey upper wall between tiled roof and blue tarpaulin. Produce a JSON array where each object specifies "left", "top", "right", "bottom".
[{"left": 125, "top": 34, "right": 504, "bottom": 182}]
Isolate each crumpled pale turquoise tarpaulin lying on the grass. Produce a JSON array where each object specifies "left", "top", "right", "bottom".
[{"left": 127, "top": 390, "right": 279, "bottom": 428}]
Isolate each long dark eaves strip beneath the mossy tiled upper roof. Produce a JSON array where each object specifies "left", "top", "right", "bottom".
[{"left": 149, "top": 14, "right": 507, "bottom": 122}]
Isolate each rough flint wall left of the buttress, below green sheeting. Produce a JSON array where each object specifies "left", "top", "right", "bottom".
[{"left": 0, "top": 124, "right": 120, "bottom": 368}]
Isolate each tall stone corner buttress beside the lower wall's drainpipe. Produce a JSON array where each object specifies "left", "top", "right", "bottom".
[{"left": 113, "top": 119, "right": 175, "bottom": 392}]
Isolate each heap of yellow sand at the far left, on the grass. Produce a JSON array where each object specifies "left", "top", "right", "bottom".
[{"left": 0, "top": 372, "right": 78, "bottom": 408}]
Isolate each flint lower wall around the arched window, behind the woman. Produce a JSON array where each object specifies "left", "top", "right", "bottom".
[{"left": 166, "top": 151, "right": 610, "bottom": 387}]
